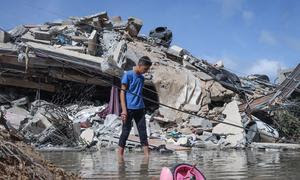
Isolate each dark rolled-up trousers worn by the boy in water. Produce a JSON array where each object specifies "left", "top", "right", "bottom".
[{"left": 119, "top": 109, "right": 148, "bottom": 148}]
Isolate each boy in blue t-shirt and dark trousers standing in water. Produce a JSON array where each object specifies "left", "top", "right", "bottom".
[{"left": 118, "top": 56, "right": 152, "bottom": 158}]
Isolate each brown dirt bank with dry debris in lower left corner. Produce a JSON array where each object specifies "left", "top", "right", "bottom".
[{"left": 0, "top": 129, "right": 81, "bottom": 180}]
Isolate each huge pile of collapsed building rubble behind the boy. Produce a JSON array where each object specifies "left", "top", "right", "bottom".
[{"left": 0, "top": 12, "right": 300, "bottom": 153}]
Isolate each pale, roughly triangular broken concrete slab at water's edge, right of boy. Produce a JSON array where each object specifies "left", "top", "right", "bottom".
[{"left": 212, "top": 101, "right": 245, "bottom": 147}]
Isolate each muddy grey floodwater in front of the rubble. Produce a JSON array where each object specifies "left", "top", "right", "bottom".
[{"left": 43, "top": 150, "right": 300, "bottom": 180}]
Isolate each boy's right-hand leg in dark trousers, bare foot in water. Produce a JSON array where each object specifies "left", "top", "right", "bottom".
[{"left": 133, "top": 109, "right": 149, "bottom": 156}]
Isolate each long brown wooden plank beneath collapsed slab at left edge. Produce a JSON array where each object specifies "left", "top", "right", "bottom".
[{"left": 0, "top": 76, "right": 55, "bottom": 92}]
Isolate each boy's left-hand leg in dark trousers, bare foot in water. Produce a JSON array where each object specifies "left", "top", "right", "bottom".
[{"left": 119, "top": 109, "right": 133, "bottom": 157}]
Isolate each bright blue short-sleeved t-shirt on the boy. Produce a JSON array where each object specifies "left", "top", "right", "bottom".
[{"left": 121, "top": 70, "right": 145, "bottom": 109}]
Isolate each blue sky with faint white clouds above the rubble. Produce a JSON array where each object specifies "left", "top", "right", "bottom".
[{"left": 0, "top": 0, "right": 300, "bottom": 80}]
